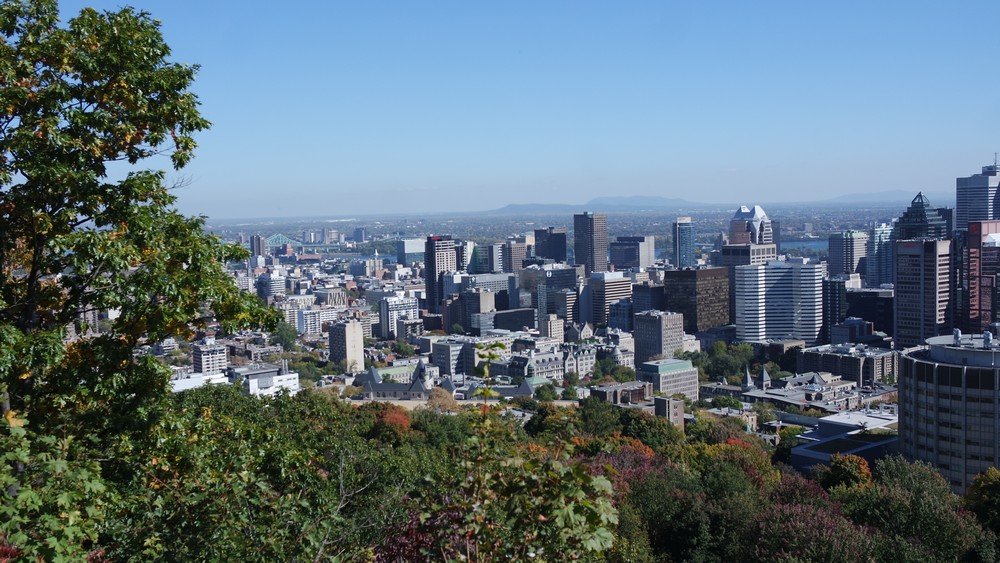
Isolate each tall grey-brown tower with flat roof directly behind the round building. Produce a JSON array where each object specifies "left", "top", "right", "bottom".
[{"left": 893, "top": 239, "right": 952, "bottom": 348}]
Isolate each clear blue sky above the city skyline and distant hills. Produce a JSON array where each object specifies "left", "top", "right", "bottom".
[{"left": 63, "top": 0, "right": 1000, "bottom": 218}]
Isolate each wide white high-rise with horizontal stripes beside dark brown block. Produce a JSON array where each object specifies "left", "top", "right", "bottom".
[{"left": 735, "top": 258, "right": 826, "bottom": 346}]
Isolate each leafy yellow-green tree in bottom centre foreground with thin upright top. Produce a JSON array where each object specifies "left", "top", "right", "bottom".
[{"left": 378, "top": 416, "right": 618, "bottom": 561}]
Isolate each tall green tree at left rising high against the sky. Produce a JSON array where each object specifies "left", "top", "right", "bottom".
[{"left": 0, "top": 0, "right": 275, "bottom": 559}]
